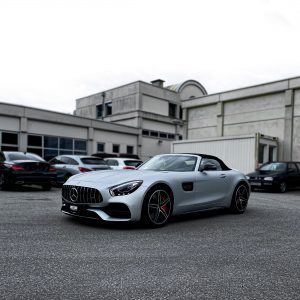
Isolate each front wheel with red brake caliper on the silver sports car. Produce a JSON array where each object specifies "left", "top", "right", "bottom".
[{"left": 142, "top": 186, "right": 173, "bottom": 228}]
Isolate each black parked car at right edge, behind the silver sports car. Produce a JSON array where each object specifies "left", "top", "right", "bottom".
[{"left": 247, "top": 161, "right": 300, "bottom": 193}]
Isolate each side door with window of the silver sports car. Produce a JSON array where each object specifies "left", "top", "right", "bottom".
[{"left": 196, "top": 158, "right": 231, "bottom": 207}]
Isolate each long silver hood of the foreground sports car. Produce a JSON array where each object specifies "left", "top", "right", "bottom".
[{"left": 65, "top": 170, "right": 169, "bottom": 187}]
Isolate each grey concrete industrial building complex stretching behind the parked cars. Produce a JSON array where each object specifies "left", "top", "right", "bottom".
[{"left": 0, "top": 77, "right": 300, "bottom": 165}]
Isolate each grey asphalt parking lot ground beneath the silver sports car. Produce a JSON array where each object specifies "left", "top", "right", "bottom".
[{"left": 0, "top": 188, "right": 300, "bottom": 299}]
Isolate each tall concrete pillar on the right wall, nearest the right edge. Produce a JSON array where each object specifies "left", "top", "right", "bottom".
[{"left": 283, "top": 90, "right": 294, "bottom": 160}]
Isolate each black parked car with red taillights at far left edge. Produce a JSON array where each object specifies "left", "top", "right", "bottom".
[{"left": 0, "top": 151, "right": 56, "bottom": 190}]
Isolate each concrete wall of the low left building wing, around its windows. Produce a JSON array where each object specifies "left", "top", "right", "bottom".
[{"left": 0, "top": 103, "right": 139, "bottom": 154}]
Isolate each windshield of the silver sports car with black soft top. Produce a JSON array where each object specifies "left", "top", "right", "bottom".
[{"left": 139, "top": 155, "right": 197, "bottom": 172}]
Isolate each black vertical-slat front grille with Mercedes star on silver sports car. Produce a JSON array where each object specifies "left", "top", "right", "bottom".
[{"left": 62, "top": 185, "right": 103, "bottom": 204}]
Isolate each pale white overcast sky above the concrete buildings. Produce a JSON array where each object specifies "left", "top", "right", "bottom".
[{"left": 0, "top": 0, "right": 300, "bottom": 113}]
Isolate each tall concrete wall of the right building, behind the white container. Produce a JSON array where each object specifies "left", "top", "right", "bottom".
[{"left": 182, "top": 78, "right": 300, "bottom": 160}]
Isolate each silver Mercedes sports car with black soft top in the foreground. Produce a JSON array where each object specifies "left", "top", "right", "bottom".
[{"left": 61, "top": 154, "right": 251, "bottom": 227}]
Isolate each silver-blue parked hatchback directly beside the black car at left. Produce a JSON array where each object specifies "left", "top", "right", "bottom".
[{"left": 49, "top": 155, "right": 111, "bottom": 184}]
